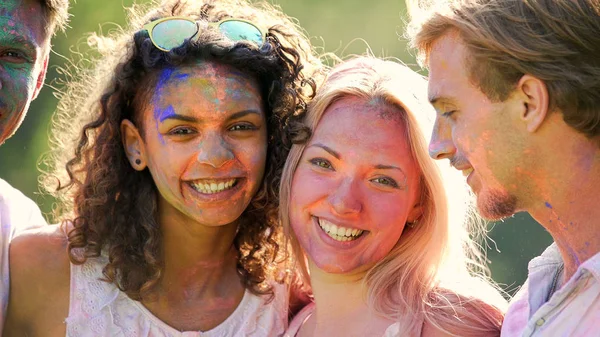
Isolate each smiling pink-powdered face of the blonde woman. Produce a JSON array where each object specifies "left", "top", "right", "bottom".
[{"left": 290, "top": 97, "right": 419, "bottom": 273}]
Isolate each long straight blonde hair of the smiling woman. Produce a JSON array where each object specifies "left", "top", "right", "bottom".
[{"left": 280, "top": 57, "right": 503, "bottom": 336}]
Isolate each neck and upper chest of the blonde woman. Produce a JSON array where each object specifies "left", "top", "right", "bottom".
[{"left": 305, "top": 262, "right": 393, "bottom": 336}]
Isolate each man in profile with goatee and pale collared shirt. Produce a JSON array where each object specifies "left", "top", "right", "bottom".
[{"left": 410, "top": 0, "right": 600, "bottom": 337}]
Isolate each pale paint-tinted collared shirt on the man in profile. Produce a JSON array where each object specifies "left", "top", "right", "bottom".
[{"left": 501, "top": 244, "right": 600, "bottom": 337}]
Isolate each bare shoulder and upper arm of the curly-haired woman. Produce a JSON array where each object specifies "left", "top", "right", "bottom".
[{"left": 4, "top": 225, "right": 70, "bottom": 336}]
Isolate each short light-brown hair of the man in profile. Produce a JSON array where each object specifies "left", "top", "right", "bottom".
[{"left": 407, "top": 0, "right": 600, "bottom": 137}]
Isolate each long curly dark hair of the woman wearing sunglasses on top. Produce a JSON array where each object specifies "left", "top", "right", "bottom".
[{"left": 44, "top": 0, "right": 321, "bottom": 300}]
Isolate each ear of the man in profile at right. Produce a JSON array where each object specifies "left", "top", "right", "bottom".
[{"left": 517, "top": 75, "right": 550, "bottom": 132}]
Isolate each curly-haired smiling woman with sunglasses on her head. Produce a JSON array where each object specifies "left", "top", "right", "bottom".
[{"left": 5, "top": 0, "right": 319, "bottom": 336}]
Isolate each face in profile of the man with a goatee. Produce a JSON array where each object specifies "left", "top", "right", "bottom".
[{"left": 429, "top": 33, "right": 524, "bottom": 219}]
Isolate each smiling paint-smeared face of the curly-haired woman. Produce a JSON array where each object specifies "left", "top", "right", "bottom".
[{"left": 143, "top": 63, "right": 267, "bottom": 226}]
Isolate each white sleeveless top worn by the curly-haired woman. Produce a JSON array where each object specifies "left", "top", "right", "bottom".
[{"left": 65, "top": 256, "right": 288, "bottom": 337}]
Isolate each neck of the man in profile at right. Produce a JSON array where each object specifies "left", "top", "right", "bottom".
[{"left": 528, "top": 135, "right": 600, "bottom": 281}]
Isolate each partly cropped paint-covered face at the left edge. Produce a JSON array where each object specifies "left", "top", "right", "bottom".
[{"left": 0, "top": 0, "right": 49, "bottom": 144}]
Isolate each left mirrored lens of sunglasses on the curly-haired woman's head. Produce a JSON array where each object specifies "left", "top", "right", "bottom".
[{"left": 152, "top": 19, "right": 198, "bottom": 50}]
